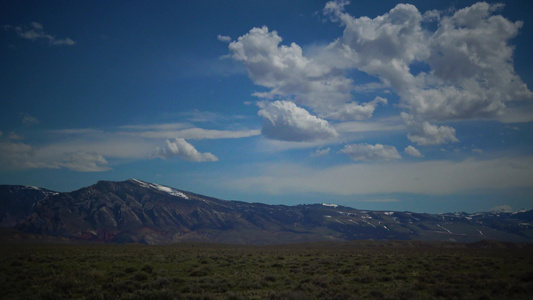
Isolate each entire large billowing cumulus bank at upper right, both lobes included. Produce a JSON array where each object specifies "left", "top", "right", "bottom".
[{"left": 229, "top": 1, "right": 533, "bottom": 145}]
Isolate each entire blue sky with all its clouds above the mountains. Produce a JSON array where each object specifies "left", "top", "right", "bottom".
[{"left": 0, "top": 0, "right": 533, "bottom": 213}]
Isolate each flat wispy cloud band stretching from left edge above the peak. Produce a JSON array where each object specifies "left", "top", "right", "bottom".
[{"left": 0, "top": 115, "right": 260, "bottom": 172}]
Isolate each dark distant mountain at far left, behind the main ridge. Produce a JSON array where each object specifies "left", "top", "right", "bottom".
[{"left": 0, "top": 185, "right": 56, "bottom": 227}]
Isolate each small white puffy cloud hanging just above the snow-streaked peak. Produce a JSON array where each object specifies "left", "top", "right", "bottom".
[{"left": 155, "top": 138, "right": 218, "bottom": 162}]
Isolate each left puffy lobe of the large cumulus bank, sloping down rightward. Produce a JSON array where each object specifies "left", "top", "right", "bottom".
[{"left": 229, "top": 26, "right": 353, "bottom": 116}]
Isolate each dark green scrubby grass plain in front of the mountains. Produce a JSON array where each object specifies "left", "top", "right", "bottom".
[{"left": 0, "top": 241, "right": 533, "bottom": 299}]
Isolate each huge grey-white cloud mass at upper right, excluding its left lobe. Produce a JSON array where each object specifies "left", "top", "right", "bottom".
[{"left": 324, "top": 2, "right": 533, "bottom": 121}]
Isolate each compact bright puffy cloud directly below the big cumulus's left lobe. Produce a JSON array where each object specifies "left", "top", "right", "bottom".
[{"left": 257, "top": 101, "right": 338, "bottom": 142}]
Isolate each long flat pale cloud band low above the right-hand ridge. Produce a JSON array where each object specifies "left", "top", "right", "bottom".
[{"left": 227, "top": 156, "right": 533, "bottom": 196}]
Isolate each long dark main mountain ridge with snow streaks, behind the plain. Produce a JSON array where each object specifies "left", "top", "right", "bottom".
[{"left": 6, "top": 179, "right": 533, "bottom": 244}]
